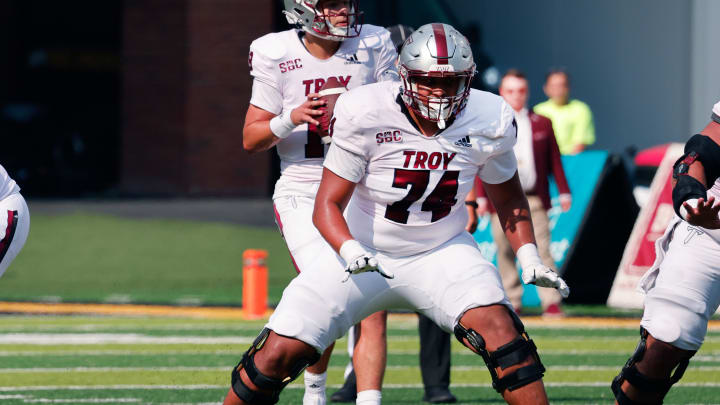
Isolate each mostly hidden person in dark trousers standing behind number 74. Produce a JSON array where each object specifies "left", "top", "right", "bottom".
[{"left": 330, "top": 24, "right": 456, "bottom": 404}]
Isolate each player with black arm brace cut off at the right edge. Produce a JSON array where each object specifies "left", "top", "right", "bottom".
[{"left": 611, "top": 102, "right": 720, "bottom": 405}]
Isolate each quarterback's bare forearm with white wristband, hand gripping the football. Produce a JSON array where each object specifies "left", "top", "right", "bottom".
[{"left": 243, "top": 93, "right": 325, "bottom": 153}]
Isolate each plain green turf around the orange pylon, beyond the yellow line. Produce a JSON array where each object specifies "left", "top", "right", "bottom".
[{"left": 0, "top": 213, "right": 296, "bottom": 305}]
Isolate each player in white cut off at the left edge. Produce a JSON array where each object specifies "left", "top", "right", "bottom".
[{"left": 0, "top": 166, "right": 30, "bottom": 276}]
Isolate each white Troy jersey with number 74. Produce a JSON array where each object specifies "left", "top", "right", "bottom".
[{"left": 324, "top": 82, "right": 517, "bottom": 256}]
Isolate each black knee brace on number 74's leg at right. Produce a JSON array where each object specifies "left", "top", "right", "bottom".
[{"left": 454, "top": 311, "right": 545, "bottom": 394}]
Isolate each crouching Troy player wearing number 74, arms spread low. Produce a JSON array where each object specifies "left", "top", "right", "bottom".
[{"left": 225, "top": 24, "right": 569, "bottom": 404}]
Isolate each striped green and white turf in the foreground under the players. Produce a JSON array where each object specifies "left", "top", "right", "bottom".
[{"left": 0, "top": 315, "right": 720, "bottom": 405}]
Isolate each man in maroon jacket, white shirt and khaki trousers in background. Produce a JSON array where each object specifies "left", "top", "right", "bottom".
[{"left": 477, "top": 69, "right": 571, "bottom": 316}]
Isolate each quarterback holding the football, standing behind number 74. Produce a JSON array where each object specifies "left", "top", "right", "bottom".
[{"left": 243, "top": 0, "right": 397, "bottom": 405}]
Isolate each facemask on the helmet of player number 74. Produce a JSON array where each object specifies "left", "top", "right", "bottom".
[{"left": 400, "top": 66, "right": 475, "bottom": 129}]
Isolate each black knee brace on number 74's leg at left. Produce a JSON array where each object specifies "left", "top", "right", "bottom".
[{"left": 230, "top": 328, "right": 320, "bottom": 405}]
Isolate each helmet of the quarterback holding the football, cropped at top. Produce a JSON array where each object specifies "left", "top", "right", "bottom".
[{"left": 283, "top": 0, "right": 363, "bottom": 41}]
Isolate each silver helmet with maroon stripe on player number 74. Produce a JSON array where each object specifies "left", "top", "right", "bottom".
[{"left": 398, "top": 23, "right": 475, "bottom": 129}]
